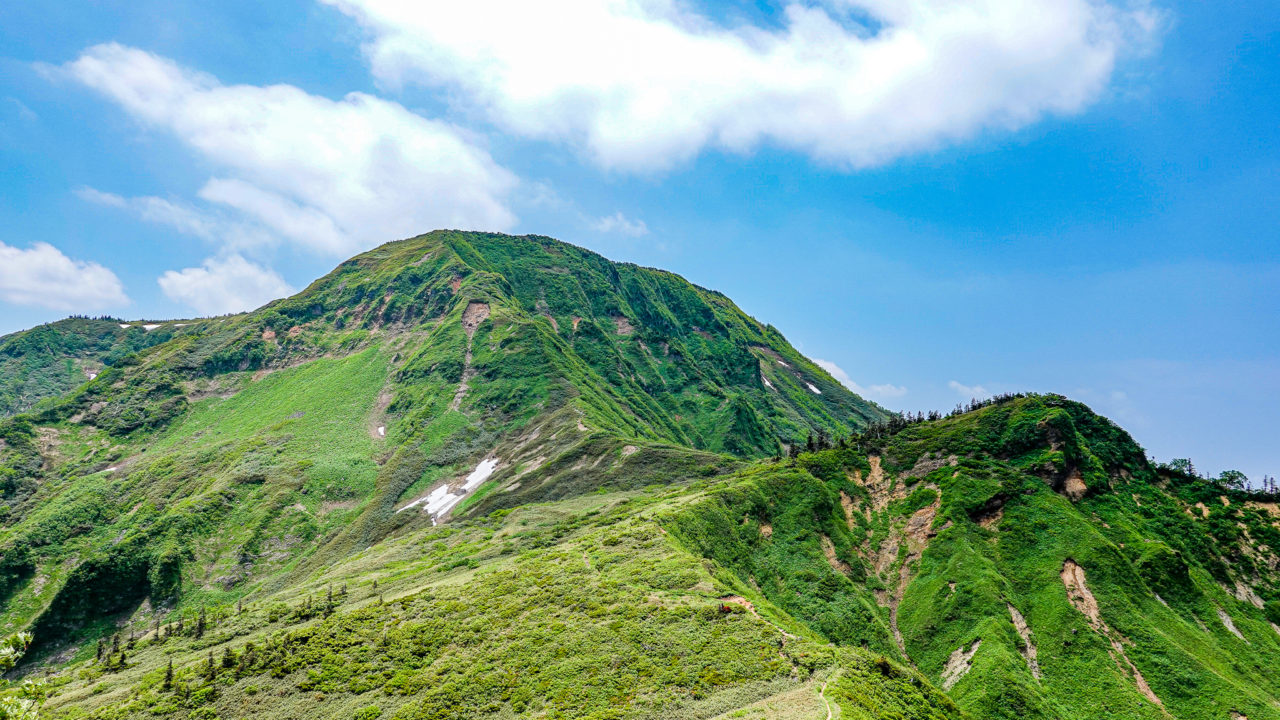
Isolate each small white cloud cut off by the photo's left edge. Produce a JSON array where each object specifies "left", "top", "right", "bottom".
[{"left": 0, "top": 242, "right": 129, "bottom": 313}]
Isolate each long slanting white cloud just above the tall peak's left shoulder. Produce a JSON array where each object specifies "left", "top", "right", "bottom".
[{"left": 60, "top": 44, "right": 517, "bottom": 256}]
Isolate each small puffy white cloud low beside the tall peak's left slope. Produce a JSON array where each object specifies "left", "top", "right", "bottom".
[{"left": 157, "top": 255, "right": 293, "bottom": 315}]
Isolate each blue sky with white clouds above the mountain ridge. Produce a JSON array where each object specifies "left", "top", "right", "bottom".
[{"left": 0, "top": 0, "right": 1280, "bottom": 480}]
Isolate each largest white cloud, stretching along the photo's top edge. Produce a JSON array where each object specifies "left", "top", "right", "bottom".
[{"left": 321, "top": 0, "right": 1161, "bottom": 170}]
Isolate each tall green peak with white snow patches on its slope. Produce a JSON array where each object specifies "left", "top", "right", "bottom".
[{"left": 0, "top": 232, "right": 883, "bottom": 656}]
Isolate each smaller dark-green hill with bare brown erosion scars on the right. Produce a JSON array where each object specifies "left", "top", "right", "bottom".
[{"left": 675, "top": 396, "right": 1280, "bottom": 720}]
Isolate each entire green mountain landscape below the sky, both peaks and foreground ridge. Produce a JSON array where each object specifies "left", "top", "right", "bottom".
[{"left": 0, "top": 231, "right": 1280, "bottom": 720}]
